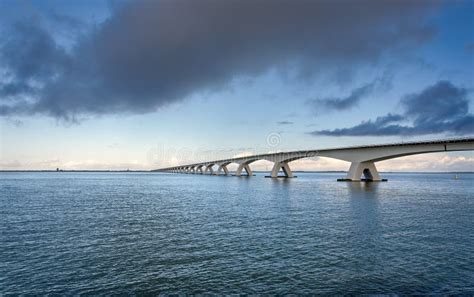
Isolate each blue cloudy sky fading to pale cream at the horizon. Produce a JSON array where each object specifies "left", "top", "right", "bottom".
[{"left": 0, "top": 0, "right": 474, "bottom": 171}]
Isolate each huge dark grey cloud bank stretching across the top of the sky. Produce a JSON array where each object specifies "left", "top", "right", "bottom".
[{"left": 0, "top": 0, "right": 435, "bottom": 119}]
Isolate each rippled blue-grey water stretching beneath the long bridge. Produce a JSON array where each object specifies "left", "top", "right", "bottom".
[{"left": 0, "top": 173, "right": 474, "bottom": 295}]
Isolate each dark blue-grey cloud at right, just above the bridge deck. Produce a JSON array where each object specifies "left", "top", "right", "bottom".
[{"left": 311, "top": 81, "right": 474, "bottom": 136}]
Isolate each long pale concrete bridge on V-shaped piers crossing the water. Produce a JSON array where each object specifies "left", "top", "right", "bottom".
[{"left": 152, "top": 138, "right": 474, "bottom": 181}]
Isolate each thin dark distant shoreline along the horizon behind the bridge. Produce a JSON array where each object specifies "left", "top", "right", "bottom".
[{"left": 0, "top": 170, "right": 474, "bottom": 174}]
